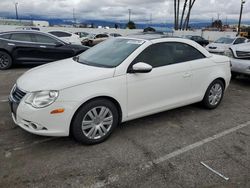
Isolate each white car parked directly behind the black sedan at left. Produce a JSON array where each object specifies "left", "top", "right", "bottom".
[{"left": 48, "top": 31, "right": 81, "bottom": 45}]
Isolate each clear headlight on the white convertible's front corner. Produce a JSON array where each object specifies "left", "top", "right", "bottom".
[{"left": 25, "top": 91, "right": 59, "bottom": 108}]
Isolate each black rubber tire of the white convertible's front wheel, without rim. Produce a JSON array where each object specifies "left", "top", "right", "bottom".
[{"left": 71, "top": 99, "right": 119, "bottom": 145}]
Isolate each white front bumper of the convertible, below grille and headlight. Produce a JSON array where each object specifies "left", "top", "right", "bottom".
[{"left": 9, "top": 98, "right": 75, "bottom": 136}]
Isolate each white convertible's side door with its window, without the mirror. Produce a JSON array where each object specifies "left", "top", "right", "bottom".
[{"left": 127, "top": 42, "right": 192, "bottom": 119}]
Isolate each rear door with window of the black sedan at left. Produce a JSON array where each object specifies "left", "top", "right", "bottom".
[{"left": 8, "top": 32, "right": 41, "bottom": 63}]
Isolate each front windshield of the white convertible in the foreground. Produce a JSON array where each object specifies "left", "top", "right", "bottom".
[{"left": 77, "top": 38, "right": 144, "bottom": 67}]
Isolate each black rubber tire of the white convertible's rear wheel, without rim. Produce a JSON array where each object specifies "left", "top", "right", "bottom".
[{"left": 202, "top": 79, "right": 225, "bottom": 109}]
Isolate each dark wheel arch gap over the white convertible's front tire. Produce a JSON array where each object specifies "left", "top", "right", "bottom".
[{"left": 69, "top": 95, "right": 123, "bottom": 134}]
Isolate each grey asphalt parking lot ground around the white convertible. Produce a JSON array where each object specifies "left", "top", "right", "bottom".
[{"left": 0, "top": 67, "right": 250, "bottom": 188}]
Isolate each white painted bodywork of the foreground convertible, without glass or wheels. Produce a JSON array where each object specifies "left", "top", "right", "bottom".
[{"left": 11, "top": 38, "right": 231, "bottom": 136}]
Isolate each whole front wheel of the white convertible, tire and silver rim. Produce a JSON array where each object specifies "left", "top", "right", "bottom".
[{"left": 71, "top": 99, "right": 119, "bottom": 145}]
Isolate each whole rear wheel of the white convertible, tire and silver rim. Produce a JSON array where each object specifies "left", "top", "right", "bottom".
[{"left": 202, "top": 79, "right": 225, "bottom": 109}]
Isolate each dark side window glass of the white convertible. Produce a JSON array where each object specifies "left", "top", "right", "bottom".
[{"left": 133, "top": 42, "right": 205, "bottom": 67}]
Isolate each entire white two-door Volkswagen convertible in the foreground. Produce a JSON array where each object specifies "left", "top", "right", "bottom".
[{"left": 9, "top": 35, "right": 231, "bottom": 144}]
